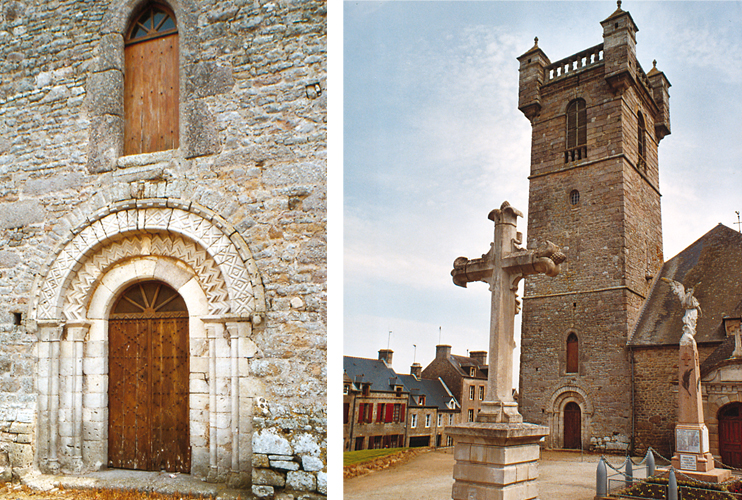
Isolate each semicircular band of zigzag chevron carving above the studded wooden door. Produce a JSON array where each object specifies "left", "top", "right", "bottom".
[{"left": 35, "top": 200, "right": 264, "bottom": 319}]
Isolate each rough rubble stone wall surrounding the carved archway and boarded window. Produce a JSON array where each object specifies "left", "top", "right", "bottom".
[{"left": 0, "top": 0, "right": 327, "bottom": 496}]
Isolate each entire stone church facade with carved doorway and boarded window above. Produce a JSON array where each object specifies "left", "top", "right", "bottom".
[{"left": 0, "top": 0, "right": 327, "bottom": 497}]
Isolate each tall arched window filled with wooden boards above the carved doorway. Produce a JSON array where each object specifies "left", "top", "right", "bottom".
[{"left": 124, "top": 4, "right": 180, "bottom": 155}]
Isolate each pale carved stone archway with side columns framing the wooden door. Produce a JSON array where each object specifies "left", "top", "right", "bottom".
[{"left": 35, "top": 199, "right": 265, "bottom": 485}]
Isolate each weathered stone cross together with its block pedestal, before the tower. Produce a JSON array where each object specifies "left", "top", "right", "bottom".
[{"left": 448, "top": 202, "right": 565, "bottom": 500}]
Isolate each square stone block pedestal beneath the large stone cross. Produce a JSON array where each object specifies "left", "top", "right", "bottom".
[{"left": 447, "top": 422, "right": 549, "bottom": 500}]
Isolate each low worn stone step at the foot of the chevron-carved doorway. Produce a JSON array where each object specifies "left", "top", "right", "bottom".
[{"left": 21, "top": 469, "right": 250, "bottom": 500}]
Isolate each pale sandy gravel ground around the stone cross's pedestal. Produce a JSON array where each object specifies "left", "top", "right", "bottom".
[{"left": 343, "top": 449, "right": 622, "bottom": 500}]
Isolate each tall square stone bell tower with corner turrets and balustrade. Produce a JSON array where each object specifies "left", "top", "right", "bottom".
[{"left": 518, "top": 1, "right": 670, "bottom": 450}]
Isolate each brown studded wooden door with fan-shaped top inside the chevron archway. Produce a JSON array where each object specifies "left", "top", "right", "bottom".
[{"left": 108, "top": 281, "right": 191, "bottom": 473}]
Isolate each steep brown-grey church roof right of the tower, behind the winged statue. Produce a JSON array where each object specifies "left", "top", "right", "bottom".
[{"left": 629, "top": 224, "right": 742, "bottom": 347}]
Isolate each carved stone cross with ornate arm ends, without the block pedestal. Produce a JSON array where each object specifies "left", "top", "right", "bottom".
[{"left": 451, "top": 201, "right": 566, "bottom": 422}]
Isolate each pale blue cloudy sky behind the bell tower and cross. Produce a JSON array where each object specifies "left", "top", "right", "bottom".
[{"left": 346, "top": 0, "right": 742, "bottom": 383}]
